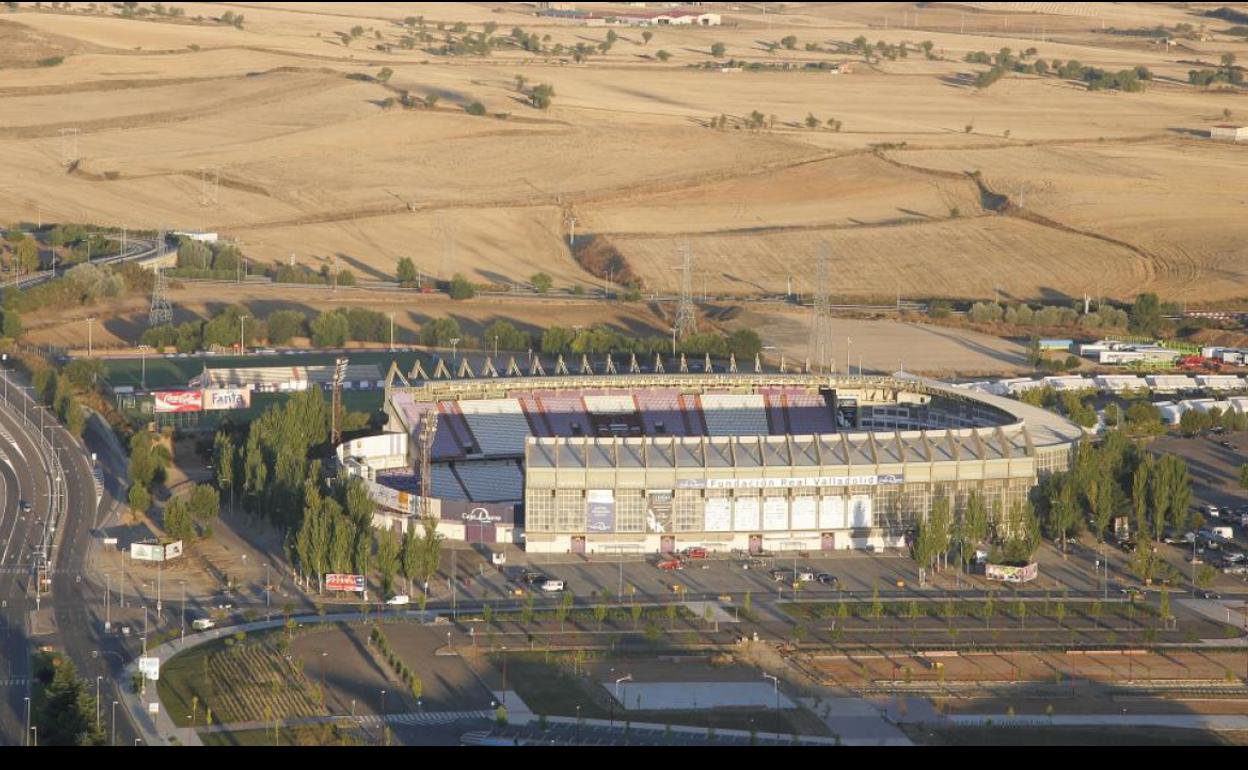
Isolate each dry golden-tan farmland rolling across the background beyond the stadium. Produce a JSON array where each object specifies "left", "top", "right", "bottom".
[{"left": 0, "top": 2, "right": 1248, "bottom": 303}]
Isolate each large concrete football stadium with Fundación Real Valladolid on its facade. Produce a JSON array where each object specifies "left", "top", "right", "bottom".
[{"left": 337, "top": 364, "right": 1083, "bottom": 554}]
